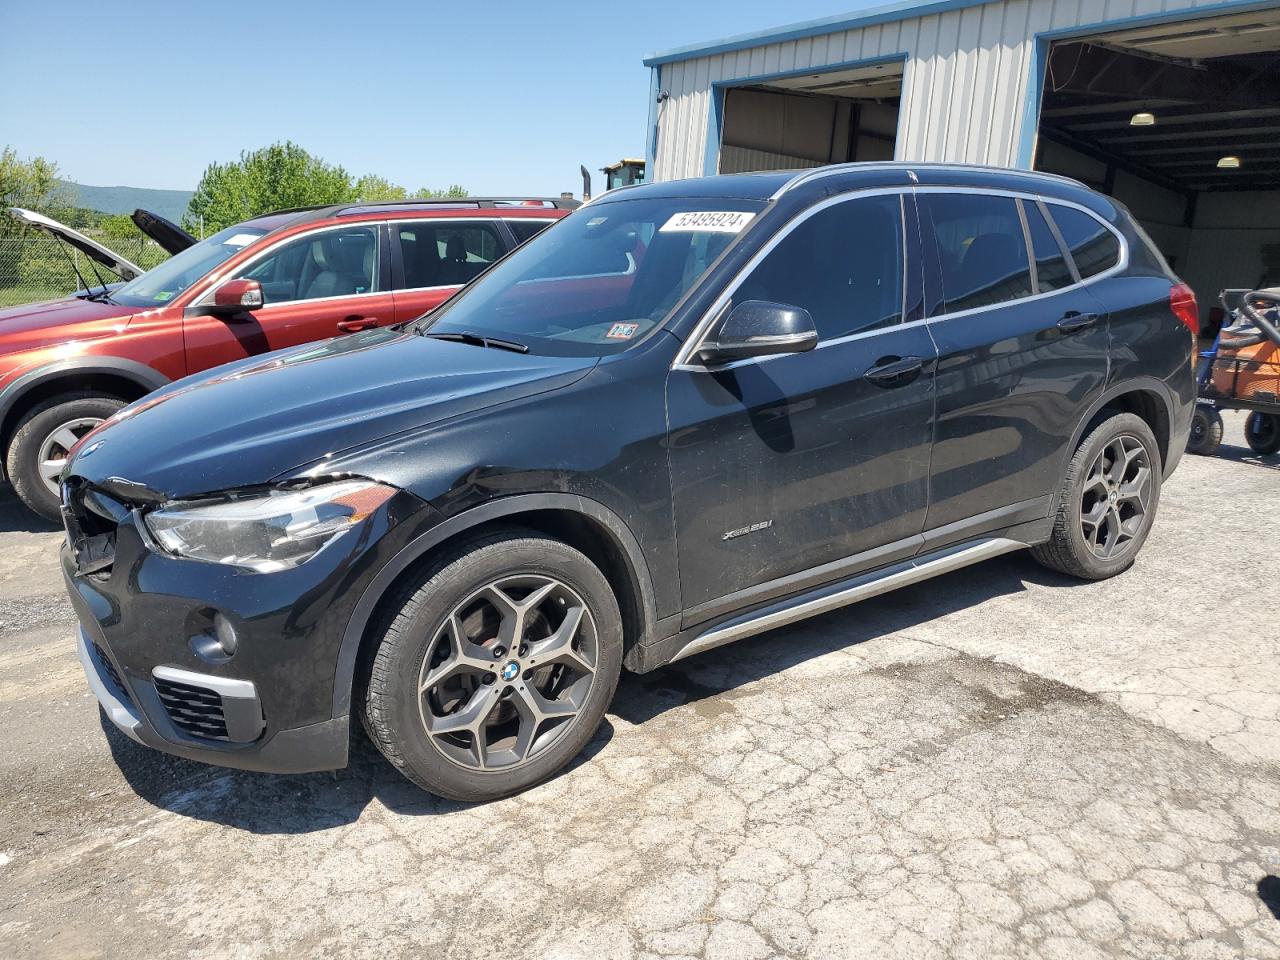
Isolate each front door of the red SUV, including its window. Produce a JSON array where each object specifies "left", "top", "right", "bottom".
[{"left": 183, "top": 224, "right": 394, "bottom": 372}]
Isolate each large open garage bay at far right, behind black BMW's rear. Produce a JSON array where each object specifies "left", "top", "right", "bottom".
[{"left": 1034, "top": 10, "right": 1280, "bottom": 333}]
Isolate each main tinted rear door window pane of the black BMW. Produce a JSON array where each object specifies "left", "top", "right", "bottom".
[{"left": 922, "top": 193, "right": 1032, "bottom": 314}]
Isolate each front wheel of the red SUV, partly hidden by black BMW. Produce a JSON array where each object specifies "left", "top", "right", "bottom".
[{"left": 5, "top": 393, "right": 124, "bottom": 524}]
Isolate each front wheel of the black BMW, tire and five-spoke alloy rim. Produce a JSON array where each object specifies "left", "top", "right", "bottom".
[{"left": 364, "top": 530, "right": 622, "bottom": 801}]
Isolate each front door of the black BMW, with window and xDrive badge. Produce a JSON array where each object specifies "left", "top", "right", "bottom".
[{"left": 667, "top": 193, "right": 934, "bottom": 625}]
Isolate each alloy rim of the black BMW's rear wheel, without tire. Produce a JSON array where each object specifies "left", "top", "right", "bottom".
[{"left": 1080, "top": 434, "right": 1152, "bottom": 559}]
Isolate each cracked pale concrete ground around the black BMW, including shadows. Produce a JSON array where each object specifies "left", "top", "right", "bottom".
[{"left": 0, "top": 419, "right": 1280, "bottom": 960}]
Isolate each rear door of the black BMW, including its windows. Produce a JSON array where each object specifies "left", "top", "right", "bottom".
[{"left": 919, "top": 188, "right": 1108, "bottom": 545}]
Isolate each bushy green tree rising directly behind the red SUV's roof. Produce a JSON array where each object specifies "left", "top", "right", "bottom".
[{"left": 183, "top": 141, "right": 356, "bottom": 236}]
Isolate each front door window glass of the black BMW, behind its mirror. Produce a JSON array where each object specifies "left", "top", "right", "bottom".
[{"left": 733, "top": 195, "right": 902, "bottom": 340}]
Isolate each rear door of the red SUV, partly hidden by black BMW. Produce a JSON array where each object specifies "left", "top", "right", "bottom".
[{"left": 390, "top": 218, "right": 513, "bottom": 323}]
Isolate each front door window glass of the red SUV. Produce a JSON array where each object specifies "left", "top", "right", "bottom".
[{"left": 239, "top": 227, "right": 378, "bottom": 303}]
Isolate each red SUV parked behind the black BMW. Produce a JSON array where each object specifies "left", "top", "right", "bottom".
[{"left": 0, "top": 198, "right": 577, "bottom": 520}]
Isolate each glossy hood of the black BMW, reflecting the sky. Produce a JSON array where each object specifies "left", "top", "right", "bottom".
[{"left": 68, "top": 329, "right": 596, "bottom": 499}]
